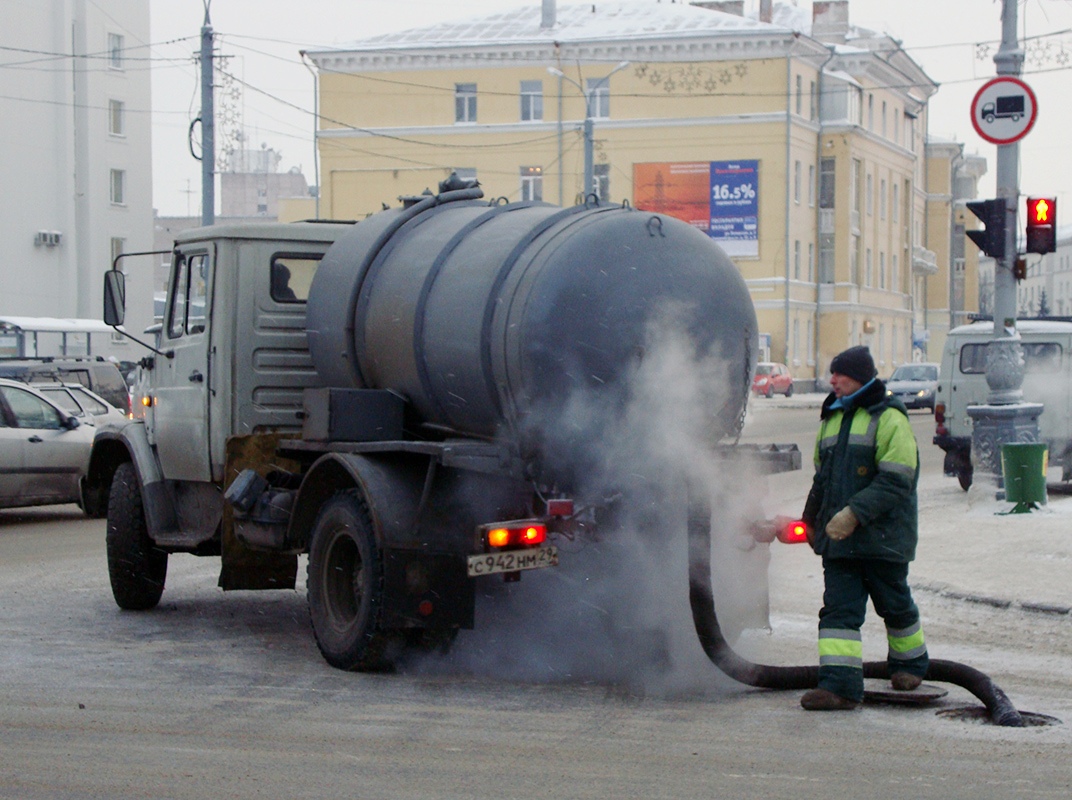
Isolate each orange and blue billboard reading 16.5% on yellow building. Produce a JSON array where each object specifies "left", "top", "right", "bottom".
[{"left": 632, "top": 160, "right": 759, "bottom": 256}]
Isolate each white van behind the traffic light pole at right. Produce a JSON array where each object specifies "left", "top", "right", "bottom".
[{"left": 934, "top": 320, "right": 1072, "bottom": 489}]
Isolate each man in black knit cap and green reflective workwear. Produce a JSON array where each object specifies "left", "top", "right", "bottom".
[{"left": 801, "top": 346, "right": 929, "bottom": 711}]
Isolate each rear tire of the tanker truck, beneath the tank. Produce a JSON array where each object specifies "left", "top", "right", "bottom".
[{"left": 308, "top": 491, "right": 391, "bottom": 671}]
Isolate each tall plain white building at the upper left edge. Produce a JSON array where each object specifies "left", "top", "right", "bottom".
[{"left": 0, "top": 0, "right": 153, "bottom": 358}]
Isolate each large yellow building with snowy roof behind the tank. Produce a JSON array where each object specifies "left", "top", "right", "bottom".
[{"left": 307, "top": 0, "right": 981, "bottom": 388}]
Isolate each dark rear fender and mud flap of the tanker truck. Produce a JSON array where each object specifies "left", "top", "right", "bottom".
[{"left": 287, "top": 453, "right": 428, "bottom": 550}]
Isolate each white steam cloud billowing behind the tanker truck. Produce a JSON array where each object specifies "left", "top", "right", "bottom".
[{"left": 419, "top": 307, "right": 766, "bottom": 693}]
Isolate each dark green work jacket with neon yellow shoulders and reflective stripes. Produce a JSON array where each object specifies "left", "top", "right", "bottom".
[{"left": 804, "top": 381, "right": 920, "bottom": 562}]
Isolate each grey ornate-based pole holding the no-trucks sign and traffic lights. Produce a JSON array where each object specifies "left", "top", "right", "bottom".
[{"left": 968, "top": 0, "right": 1042, "bottom": 486}]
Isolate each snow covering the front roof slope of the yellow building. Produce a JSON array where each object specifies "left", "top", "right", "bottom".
[{"left": 323, "top": 0, "right": 793, "bottom": 51}]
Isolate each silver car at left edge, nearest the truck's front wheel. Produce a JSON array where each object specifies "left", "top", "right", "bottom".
[{"left": 0, "top": 379, "right": 94, "bottom": 508}]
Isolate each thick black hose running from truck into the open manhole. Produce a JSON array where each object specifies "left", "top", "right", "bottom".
[{"left": 688, "top": 498, "right": 1024, "bottom": 728}]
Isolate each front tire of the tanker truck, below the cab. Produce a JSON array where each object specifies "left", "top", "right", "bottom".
[{"left": 105, "top": 461, "right": 167, "bottom": 611}]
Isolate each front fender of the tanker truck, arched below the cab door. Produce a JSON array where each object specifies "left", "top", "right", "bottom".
[{"left": 83, "top": 420, "right": 178, "bottom": 536}]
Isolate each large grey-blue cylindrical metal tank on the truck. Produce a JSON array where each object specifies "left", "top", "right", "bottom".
[{"left": 307, "top": 188, "right": 758, "bottom": 461}]
